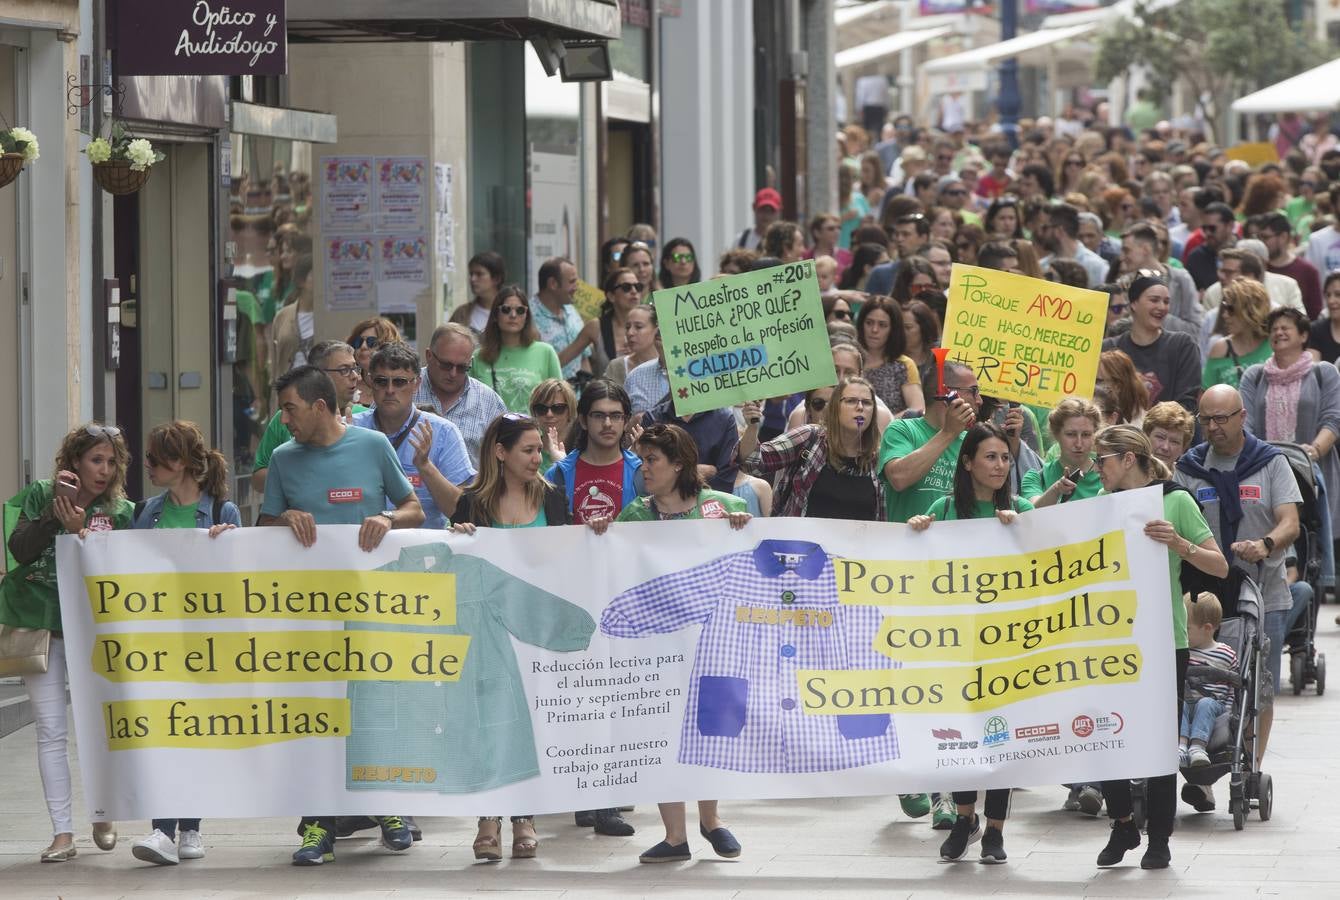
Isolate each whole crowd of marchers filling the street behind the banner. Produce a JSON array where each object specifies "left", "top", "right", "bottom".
[{"left": 0, "top": 105, "right": 1340, "bottom": 868}]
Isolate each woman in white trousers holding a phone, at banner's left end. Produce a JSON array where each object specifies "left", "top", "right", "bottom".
[{"left": 0, "top": 422, "right": 134, "bottom": 863}]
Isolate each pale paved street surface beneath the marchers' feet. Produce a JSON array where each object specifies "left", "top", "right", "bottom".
[{"left": 0, "top": 616, "right": 1340, "bottom": 900}]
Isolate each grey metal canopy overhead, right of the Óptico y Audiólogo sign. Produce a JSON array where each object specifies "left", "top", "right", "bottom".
[{"left": 288, "top": 0, "right": 622, "bottom": 44}]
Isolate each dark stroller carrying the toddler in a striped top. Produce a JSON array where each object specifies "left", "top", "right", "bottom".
[{"left": 1182, "top": 573, "right": 1274, "bottom": 830}]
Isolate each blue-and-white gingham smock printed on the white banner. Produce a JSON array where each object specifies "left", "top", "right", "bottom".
[{"left": 600, "top": 541, "right": 898, "bottom": 773}]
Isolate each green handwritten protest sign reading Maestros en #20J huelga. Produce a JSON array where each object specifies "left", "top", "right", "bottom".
[{"left": 651, "top": 260, "right": 838, "bottom": 415}]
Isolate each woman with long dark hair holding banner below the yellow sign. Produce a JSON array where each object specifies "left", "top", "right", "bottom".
[{"left": 907, "top": 422, "right": 1033, "bottom": 864}]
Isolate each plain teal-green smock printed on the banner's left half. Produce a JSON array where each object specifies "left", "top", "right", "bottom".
[{"left": 344, "top": 544, "right": 595, "bottom": 794}]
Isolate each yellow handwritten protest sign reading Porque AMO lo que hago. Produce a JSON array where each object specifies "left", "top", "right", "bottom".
[{"left": 941, "top": 264, "right": 1107, "bottom": 406}]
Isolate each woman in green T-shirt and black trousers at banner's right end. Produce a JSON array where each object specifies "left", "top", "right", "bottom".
[{"left": 1093, "top": 425, "right": 1229, "bottom": 869}]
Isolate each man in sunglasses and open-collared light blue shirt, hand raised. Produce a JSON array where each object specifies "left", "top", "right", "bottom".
[{"left": 354, "top": 343, "right": 474, "bottom": 528}]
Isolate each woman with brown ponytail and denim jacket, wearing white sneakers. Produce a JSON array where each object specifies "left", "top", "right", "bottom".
[{"left": 130, "top": 423, "right": 241, "bottom": 865}]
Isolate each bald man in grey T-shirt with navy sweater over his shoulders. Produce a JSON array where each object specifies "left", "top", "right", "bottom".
[{"left": 1174, "top": 384, "right": 1302, "bottom": 810}]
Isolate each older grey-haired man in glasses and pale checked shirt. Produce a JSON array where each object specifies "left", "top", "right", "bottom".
[{"left": 414, "top": 321, "right": 507, "bottom": 467}]
